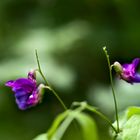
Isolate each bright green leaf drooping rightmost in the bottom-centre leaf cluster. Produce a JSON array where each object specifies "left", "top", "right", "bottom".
[{"left": 75, "top": 113, "right": 98, "bottom": 140}]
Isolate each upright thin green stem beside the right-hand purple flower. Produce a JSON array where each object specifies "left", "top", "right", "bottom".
[{"left": 103, "top": 47, "right": 119, "bottom": 133}]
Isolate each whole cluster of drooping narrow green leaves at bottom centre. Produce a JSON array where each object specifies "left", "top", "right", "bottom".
[{"left": 34, "top": 102, "right": 98, "bottom": 140}]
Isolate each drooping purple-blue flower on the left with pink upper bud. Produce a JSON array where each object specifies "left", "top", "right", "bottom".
[{"left": 5, "top": 70, "right": 41, "bottom": 110}]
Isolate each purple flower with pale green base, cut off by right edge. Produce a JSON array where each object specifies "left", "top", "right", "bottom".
[{"left": 113, "top": 58, "right": 140, "bottom": 84}]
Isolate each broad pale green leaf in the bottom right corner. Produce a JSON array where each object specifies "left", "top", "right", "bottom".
[{"left": 112, "top": 107, "right": 140, "bottom": 140}]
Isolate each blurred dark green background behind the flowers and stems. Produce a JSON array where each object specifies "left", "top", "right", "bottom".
[{"left": 0, "top": 0, "right": 140, "bottom": 140}]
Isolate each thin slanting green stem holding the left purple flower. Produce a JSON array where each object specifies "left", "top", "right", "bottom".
[{"left": 35, "top": 50, "right": 67, "bottom": 110}]
